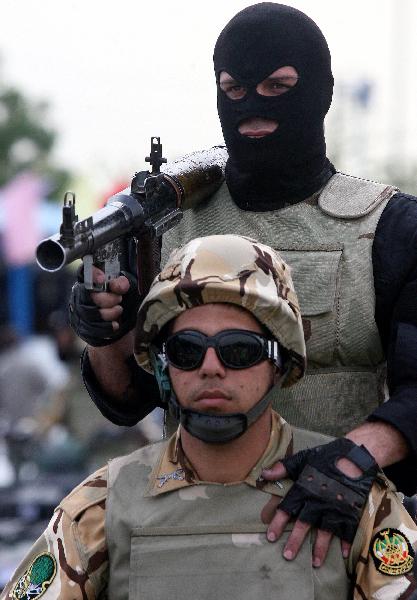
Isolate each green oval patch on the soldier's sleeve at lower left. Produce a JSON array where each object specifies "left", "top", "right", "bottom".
[{"left": 12, "top": 552, "right": 56, "bottom": 600}]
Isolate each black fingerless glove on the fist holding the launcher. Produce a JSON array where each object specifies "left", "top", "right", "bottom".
[{"left": 68, "top": 268, "right": 139, "bottom": 347}]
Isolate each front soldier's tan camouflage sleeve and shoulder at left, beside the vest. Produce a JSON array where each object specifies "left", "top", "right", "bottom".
[{"left": 0, "top": 467, "right": 108, "bottom": 600}]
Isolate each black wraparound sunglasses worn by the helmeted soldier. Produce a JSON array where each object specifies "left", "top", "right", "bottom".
[{"left": 163, "top": 329, "right": 281, "bottom": 371}]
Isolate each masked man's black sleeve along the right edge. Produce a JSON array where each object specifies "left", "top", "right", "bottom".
[{"left": 369, "top": 193, "right": 417, "bottom": 495}]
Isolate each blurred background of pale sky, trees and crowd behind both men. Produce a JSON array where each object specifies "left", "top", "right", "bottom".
[{"left": 0, "top": 0, "right": 417, "bottom": 589}]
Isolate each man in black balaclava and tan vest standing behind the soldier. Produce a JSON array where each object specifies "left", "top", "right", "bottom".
[{"left": 71, "top": 2, "right": 417, "bottom": 554}]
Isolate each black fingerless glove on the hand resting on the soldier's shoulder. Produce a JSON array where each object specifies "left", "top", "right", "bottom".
[{"left": 279, "top": 438, "right": 378, "bottom": 542}]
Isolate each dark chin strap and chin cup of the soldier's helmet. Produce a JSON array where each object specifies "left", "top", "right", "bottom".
[{"left": 150, "top": 351, "right": 276, "bottom": 444}]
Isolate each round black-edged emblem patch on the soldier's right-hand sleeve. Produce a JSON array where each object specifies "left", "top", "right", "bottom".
[{"left": 370, "top": 527, "right": 414, "bottom": 576}]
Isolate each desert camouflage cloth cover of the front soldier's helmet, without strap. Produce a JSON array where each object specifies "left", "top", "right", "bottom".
[{"left": 135, "top": 235, "right": 306, "bottom": 387}]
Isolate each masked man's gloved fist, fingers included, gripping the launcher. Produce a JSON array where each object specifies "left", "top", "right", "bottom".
[{"left": 69, "top": 267, "right": 139, "bottom": 347}]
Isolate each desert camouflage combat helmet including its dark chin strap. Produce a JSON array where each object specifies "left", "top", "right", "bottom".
[{"left": 135, "top": 235, "right": 305, "bottom": 443}]
